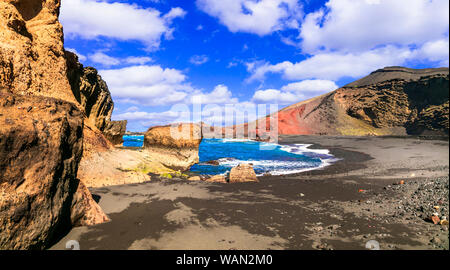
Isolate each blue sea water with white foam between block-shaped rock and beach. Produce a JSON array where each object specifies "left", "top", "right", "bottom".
[{"left": 191, "top": 139, "right": 336, "bottom": 175}]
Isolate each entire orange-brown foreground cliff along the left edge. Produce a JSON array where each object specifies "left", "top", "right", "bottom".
[{"left": 0, "top": 0, "right": 107, "bottom": 249}]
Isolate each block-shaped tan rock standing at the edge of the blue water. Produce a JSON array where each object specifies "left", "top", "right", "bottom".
[{"left": 144, "top": 123, "right": 202, "bottom": 171}]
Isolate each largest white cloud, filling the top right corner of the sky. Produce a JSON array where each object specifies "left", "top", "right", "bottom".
[{"left": 300, "top": 0, "right": 449, "bottom": 53}]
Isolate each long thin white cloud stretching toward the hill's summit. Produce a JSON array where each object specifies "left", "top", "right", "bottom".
[{"left": 247, "top": 46, "right": 416, "bottom": 81}]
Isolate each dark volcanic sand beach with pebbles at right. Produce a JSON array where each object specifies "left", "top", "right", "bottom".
[{"left": 52, "top": 136, "right": 449, "bottom": 250}]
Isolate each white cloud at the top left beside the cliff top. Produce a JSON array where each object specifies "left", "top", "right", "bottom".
[{"left": 60, "top": 0, "right": 186, "bottom": 49}]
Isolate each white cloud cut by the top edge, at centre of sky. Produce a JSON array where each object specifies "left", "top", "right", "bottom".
[{"left": 197, "top": 0, "right": 302, "bottom": 36}]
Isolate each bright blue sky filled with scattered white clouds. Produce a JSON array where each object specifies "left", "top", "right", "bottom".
[{"left": 60, "top": 0, "right": 449, "bottom": 131}]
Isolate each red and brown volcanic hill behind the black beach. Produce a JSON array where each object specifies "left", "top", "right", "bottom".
[{"left": 233, "top": 67, "right": 449, "bottom": 138}]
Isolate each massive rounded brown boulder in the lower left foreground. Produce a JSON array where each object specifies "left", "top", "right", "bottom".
[{"left": 0, "top": 93, "right": 107, "bottom": 249}]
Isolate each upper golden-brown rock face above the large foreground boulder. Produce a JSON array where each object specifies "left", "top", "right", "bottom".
[{"left": 0, "top": 0, "right": 75, "bottom": 102}]
